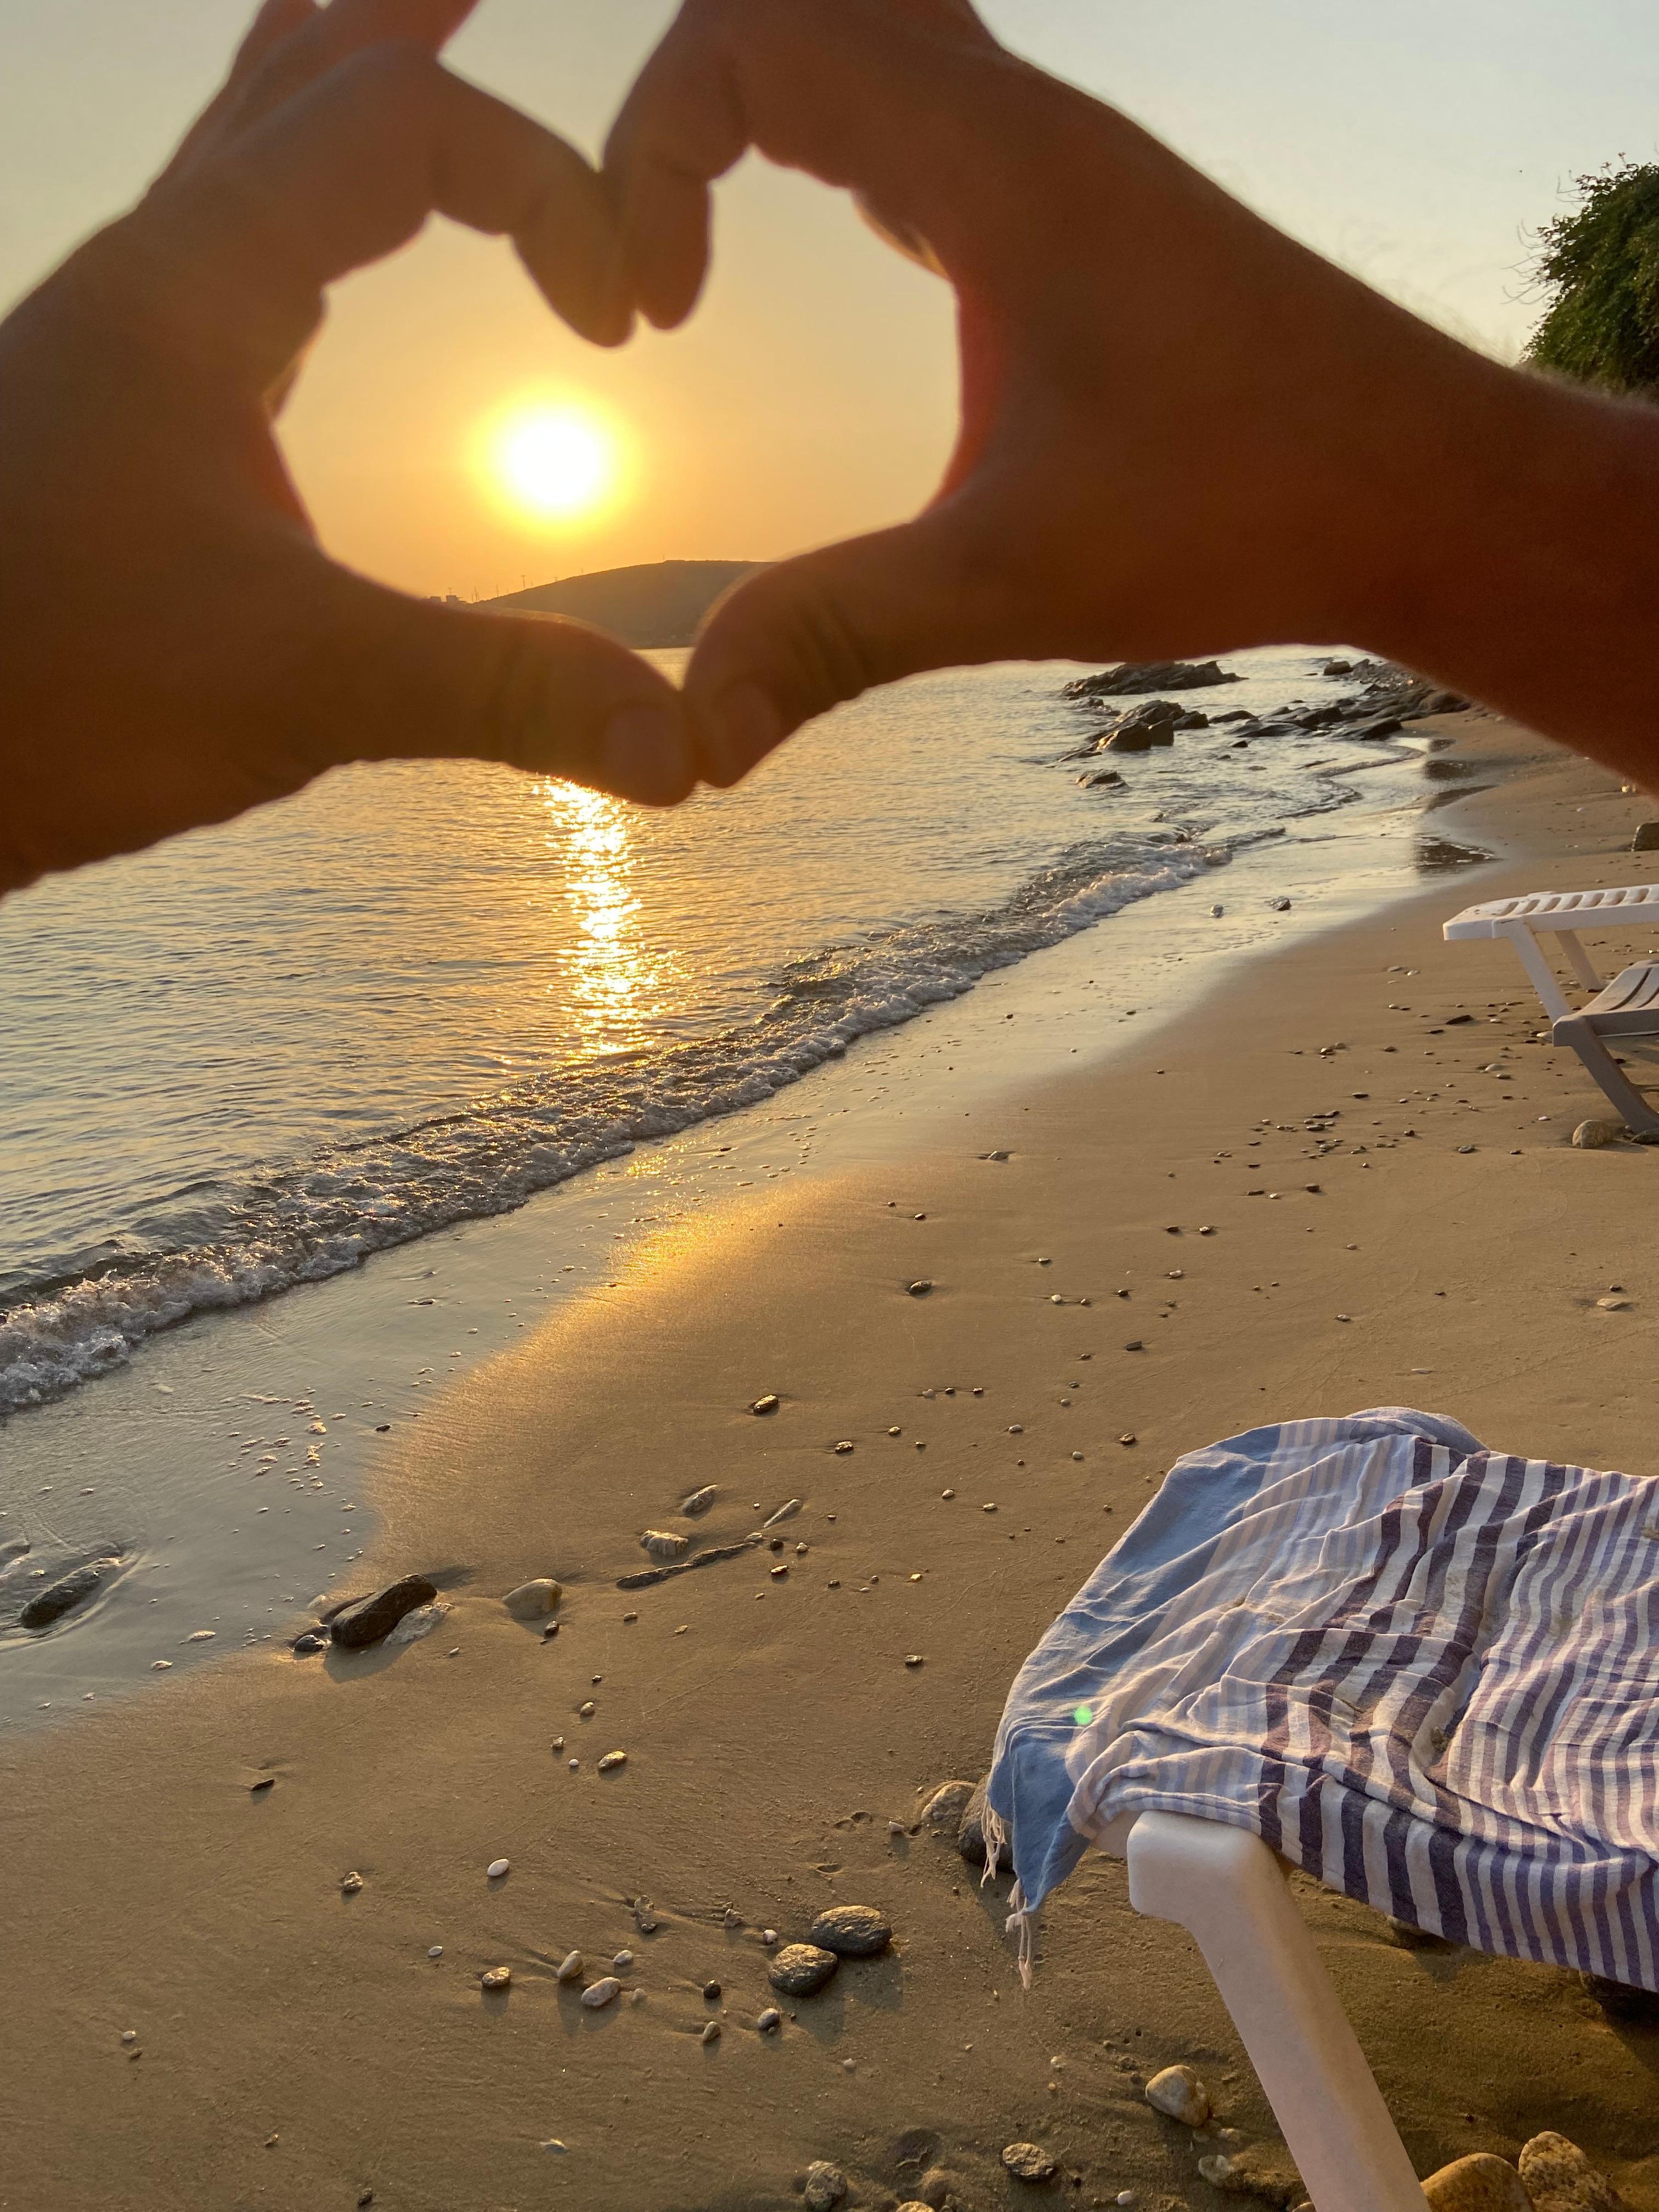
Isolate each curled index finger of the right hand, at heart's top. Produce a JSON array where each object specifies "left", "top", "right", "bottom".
[{"left": 604, "top": 0, "right": 1013, "bottom": 328}]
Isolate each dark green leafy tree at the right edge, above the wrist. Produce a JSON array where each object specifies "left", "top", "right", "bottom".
[{"left": 1526, "top": 161, "right": 1659, "bottom": 394}]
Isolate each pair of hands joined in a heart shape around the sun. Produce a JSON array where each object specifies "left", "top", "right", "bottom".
[{"left": 0, "top": 0, "right": 1659, "bottom": 891}]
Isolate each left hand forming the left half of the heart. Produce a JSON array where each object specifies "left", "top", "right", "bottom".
[{"left": 0, "top": 0, "right": 692, "bottom": 891}]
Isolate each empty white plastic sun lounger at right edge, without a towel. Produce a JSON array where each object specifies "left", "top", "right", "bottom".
[{"left": 1442, "top": 883, "right": 1659, "bottom": 1137}]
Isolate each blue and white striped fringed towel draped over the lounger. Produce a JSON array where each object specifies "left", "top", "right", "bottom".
[{"left": 991, "top": 1407, "right": 1659, "bottom": 1991}]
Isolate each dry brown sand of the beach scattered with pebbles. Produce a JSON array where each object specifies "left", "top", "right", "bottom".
[{"left": 0, "top": 716, "right": 1659, "bottom": 2212}]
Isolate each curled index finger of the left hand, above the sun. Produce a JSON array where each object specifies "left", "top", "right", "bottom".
[{"left": 133, "top": 44, "right": 628, "bottom": 376}]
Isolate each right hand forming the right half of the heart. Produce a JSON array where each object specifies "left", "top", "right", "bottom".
[{"left": 606, "top": 0, "right": 1575, "bottom": 783}]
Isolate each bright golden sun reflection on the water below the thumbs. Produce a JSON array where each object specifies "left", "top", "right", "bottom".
[{"left": 542, "top": 783, "right": 664, "bottom": 1055}]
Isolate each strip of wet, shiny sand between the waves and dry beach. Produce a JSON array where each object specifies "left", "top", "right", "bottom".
[{"left": 0, "top": 714, "right": 1524, "bottom": 1730}]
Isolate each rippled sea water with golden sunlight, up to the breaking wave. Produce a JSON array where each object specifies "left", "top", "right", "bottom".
[{"left": 0, "top": 648, "right": 1376, "bottom": 1413}]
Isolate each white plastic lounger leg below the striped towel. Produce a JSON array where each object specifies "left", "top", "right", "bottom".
[{"left": 1126, "top": 1812, "right": 1425, "bottom": 2212}]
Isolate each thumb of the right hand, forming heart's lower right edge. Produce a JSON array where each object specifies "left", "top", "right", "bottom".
[{"left": 686, "top": 504, "right": 1029, "bottom": 783}]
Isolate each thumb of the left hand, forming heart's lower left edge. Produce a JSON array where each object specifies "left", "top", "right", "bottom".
[{"left": 274, "top": 549, "right": 695, "bottom": 805}]
